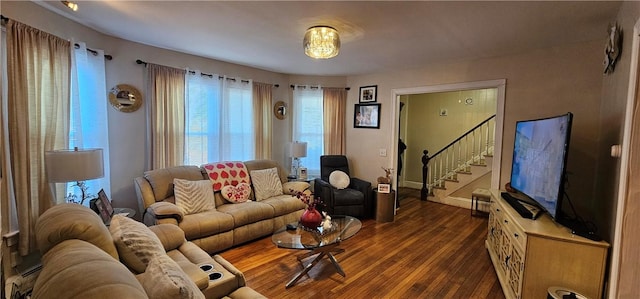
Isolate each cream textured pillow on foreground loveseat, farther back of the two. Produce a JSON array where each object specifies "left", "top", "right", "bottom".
[{"left": 109, "top": 215, "right": 166, "bottom": 273}]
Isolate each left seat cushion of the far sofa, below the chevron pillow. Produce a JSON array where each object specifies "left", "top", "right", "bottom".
[{"left": 178, "top": 211, "right": 234, "bottom": 240}]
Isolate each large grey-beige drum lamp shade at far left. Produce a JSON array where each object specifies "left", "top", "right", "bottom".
[{"left": 44, "top": 148, "right": 104, "bottom": 183}]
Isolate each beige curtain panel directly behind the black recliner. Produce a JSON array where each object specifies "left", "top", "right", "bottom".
[{"left": 322, "top": 88, "right": 347, "bottom": 155}]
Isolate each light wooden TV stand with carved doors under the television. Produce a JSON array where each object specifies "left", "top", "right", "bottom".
[{"left": 485, "top": 189, "right": 609, "bottom": 299}]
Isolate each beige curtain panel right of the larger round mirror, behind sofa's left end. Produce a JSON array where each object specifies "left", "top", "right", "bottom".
[{"left": 145, "top": 63, "right": 186, "bottom": 169}]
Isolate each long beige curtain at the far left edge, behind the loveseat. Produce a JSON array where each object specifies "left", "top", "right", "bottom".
[{"left": 1, "top": 20, "right": 71, "bottom": 255}]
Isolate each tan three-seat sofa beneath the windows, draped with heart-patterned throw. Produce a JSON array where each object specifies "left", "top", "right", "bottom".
[{"left": 134, "top": 160, "right": 309, "bottom": 254}]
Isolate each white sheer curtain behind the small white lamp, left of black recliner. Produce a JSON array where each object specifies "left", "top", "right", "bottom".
[{"left": 292, "top": 86, "right": 324, "bottom": 176}]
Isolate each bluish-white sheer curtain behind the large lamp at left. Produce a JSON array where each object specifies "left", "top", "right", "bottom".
[{"left": 65, "top": 42, "right": 111, "bottom": 205}]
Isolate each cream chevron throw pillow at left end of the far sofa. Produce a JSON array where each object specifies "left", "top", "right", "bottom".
[{"left": 173, "top": 179, "right": 216, "bottom": 215}]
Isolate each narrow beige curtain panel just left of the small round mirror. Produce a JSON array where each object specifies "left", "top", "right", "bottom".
[{"left": 253, "top": 82, "right": 273, "bottom": 159}]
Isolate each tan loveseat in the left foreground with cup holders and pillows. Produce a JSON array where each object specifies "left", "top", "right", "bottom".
[{"left": 33, "top": 204, "right": 265, "bottom": 298}]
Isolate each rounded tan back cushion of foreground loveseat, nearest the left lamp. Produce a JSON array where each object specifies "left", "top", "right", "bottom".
[{"left": 36, "top": 203, "right": 118, "bottom": 259}]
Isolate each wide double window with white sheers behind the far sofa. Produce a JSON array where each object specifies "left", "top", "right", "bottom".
[{"left": 184, "top": 72, "right": 255, "bottom": 165}]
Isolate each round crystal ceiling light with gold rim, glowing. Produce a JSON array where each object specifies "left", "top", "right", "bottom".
[{"left": 302, "top": 26, "right": 340, "bottom": 59}]
